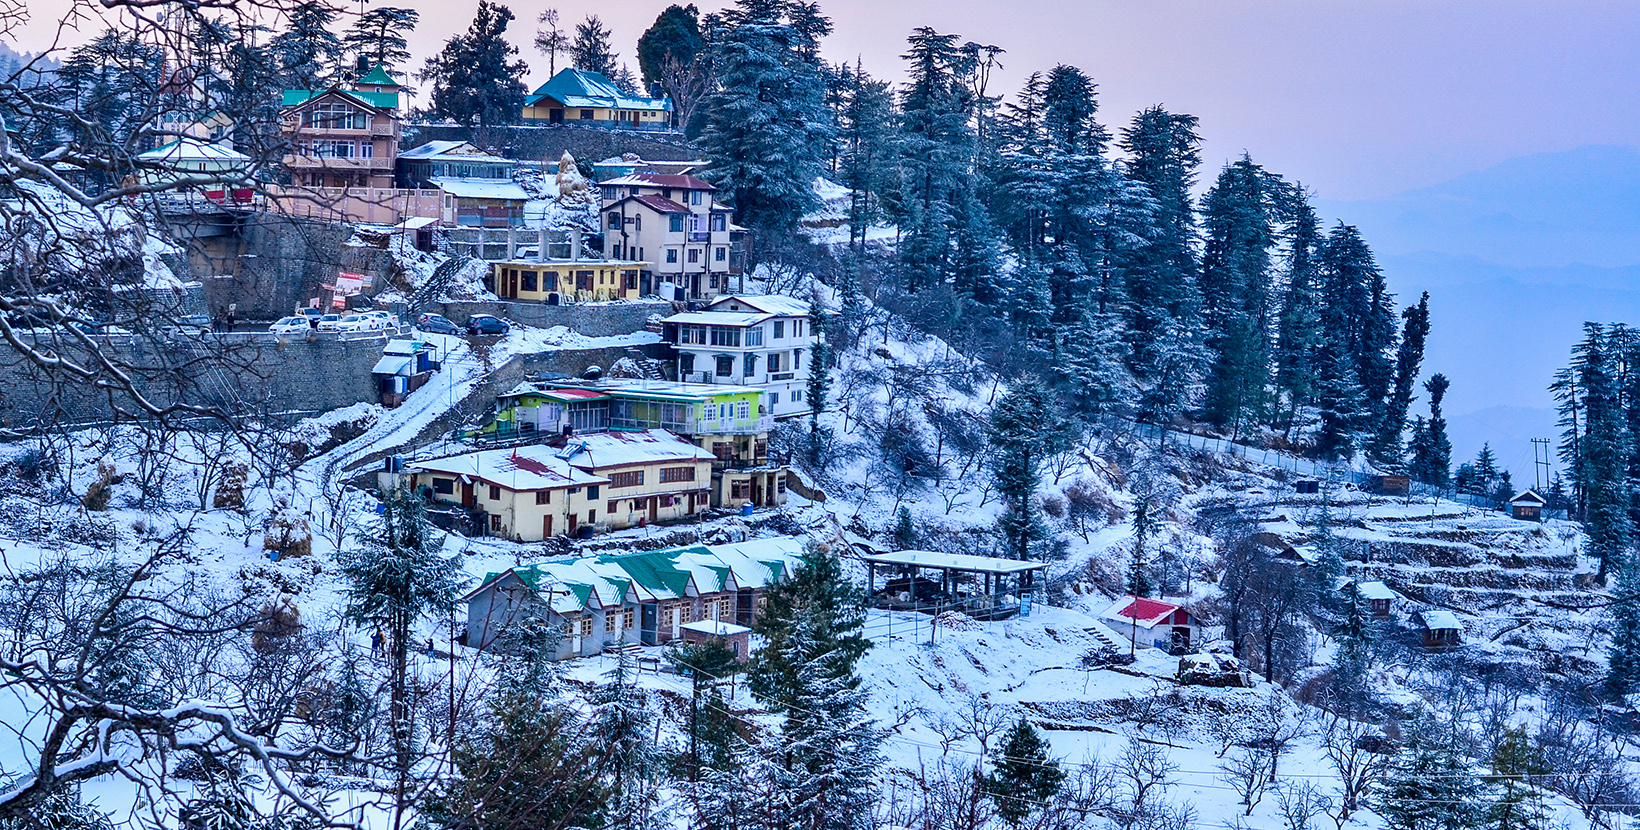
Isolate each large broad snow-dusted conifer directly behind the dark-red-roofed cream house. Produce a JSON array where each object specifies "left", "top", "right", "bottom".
[{"left": 700, "top": 0, "right": 831, "bottom": 238}]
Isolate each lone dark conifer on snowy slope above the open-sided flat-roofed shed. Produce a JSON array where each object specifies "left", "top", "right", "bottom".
[{"left": 991, "top": 379, "right": 1058, "bottom": 559}]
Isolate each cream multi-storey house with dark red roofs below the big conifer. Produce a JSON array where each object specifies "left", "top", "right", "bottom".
[{"left": 599, "top": 172, "right": 745, "bottom": 300}]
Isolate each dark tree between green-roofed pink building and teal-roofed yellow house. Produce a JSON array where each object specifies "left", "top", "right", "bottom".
[{"left": 417, "top": 0, "right": 530, "bottom": 128}]
